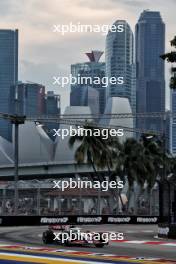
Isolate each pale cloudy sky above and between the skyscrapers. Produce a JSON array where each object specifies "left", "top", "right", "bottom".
[{"left": 0, "top": 0, "right": 176, "bottom": 111}]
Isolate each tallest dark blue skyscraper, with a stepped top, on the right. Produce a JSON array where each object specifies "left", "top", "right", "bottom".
[{"left": 136, "top": 10, "right": 165, "bottom": 131}]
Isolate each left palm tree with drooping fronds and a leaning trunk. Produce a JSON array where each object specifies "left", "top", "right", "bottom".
[{"left": 69, "top": 122, "right": 123, "bottom": 212}]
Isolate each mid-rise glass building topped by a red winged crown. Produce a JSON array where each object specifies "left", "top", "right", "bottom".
[{"left": 70, "top": 51, "right": 106, "bottom": 114}]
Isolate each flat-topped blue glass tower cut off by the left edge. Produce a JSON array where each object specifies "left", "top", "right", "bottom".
[{"left": 0, "top": 29, "right": 18, "bottom": 141}]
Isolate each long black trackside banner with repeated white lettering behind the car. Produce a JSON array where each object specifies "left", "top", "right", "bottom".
[{"left": 0, "top": 215, "right": 160, "bottom": 226}]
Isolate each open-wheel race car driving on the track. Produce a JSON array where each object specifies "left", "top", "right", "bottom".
[{"left": 42, "top": 225, "right": 108, "bottom": 248}]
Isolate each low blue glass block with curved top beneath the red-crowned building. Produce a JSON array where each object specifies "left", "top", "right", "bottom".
[{"left": 70, "top": 86, "right": 99, "bottom": 115}]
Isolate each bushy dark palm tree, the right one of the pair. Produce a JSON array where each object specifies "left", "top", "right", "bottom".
[{"left": 116, "top": 134, "right": 163, "bottom": 213}]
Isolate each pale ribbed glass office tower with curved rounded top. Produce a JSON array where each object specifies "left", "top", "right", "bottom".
[{"left": 105, "top": 20, "right": 136, "bottom": 113}]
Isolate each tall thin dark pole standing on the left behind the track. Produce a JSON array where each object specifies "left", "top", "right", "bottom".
[{"left": 14, "top": 120, "right": 19, "bottom": 215}]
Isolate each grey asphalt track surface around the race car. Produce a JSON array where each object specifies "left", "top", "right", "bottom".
[{"left": 0, "top": 225, "right": 176, "bottom": 263}]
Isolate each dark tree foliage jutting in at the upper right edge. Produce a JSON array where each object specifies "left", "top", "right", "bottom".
[{"left": 160, "top": 36, "right": 176, "bottom": 90}]
